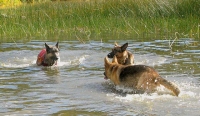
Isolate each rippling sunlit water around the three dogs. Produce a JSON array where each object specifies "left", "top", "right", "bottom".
[{"left": 0, "top": 39, "right": 200, "bottom": 116}]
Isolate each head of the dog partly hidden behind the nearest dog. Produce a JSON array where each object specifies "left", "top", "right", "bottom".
[{"left": 107, "top": 43, "right": 128, "bottom": 58}]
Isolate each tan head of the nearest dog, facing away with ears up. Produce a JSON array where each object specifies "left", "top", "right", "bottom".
[{"left": 104, "top": 56, "right": 118, "bottom": 79}]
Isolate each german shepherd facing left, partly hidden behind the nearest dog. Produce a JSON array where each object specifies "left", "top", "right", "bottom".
[{"left": 107, "top": 43, "right": 134, "bottom": 65}]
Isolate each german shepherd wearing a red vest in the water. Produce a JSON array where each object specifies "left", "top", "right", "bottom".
[{"left": 36, "top": 42, "right": 60, "bottom": 66}]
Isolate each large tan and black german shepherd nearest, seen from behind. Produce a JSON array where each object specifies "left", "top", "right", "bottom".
[{"left": 104, "top": 56, "right": 180, "bottom": 96}]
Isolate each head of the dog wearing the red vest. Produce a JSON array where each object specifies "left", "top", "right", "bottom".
[{"left": 44, "top": 42, "right": 60, "bottom": 66}]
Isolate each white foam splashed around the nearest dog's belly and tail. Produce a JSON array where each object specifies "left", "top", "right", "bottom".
[{"left": 106, "top": 79, "right": 200, "bottom": 102}]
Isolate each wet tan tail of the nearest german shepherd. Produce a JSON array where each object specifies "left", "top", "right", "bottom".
[{"left": 160, "top": 77, "right": 180, "bottom": 96}]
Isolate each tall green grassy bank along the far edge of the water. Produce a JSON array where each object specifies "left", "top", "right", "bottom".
[{"left": 0, "top": 0, "right": 200, "bottom": 41}]
